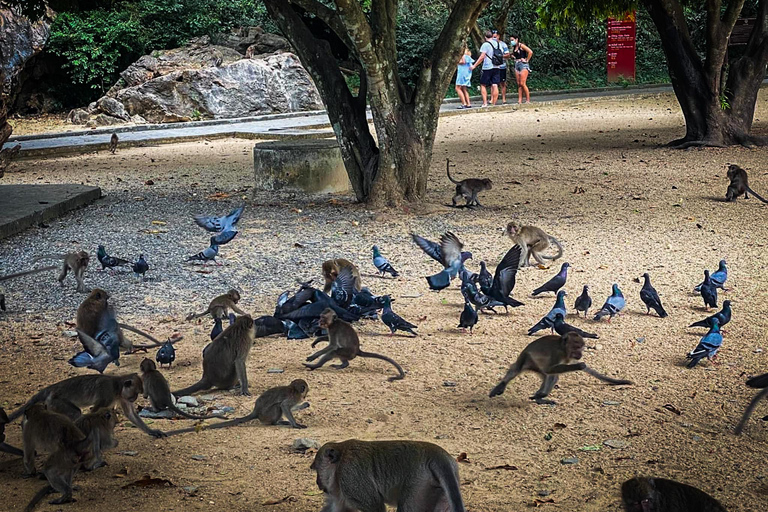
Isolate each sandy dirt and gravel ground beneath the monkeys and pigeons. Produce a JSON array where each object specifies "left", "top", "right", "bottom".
[{"left": 0, "top": 91, "right": 768, "bottom": 512}]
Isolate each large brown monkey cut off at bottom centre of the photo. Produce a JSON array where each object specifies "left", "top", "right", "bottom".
[{"left": 310, "top": 439, "right": 465, "bottom": 512}]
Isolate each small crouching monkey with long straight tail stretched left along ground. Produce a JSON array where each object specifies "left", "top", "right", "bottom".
[{"left": 168, "top": 379, "right": 309, "bottom": 436}]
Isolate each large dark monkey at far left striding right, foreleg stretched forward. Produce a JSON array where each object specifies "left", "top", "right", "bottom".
[{"left": 8, "top": 373, "right": 165, "bottom": 437}]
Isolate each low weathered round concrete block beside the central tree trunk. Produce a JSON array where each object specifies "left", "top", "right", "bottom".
[{"left": 253, "top": 139, "right": 352, "bottom": 194}]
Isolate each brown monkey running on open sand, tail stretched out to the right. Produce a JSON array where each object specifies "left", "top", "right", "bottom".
[{"left": 490, "top": 332, "right": 632, "bottom": 405}]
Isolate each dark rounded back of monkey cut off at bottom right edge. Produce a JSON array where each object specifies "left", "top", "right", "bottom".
[{"left": 621, "top": 477, "right": 726, "bottom": 512}]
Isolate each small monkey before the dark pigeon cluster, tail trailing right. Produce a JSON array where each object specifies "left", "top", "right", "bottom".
[{"left": 304, "top": 308, "right": 405, "bottom": 382}]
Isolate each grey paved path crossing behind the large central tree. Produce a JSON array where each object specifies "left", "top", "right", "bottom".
[{"left": 8, "top": 85, "right": 672, "bottom": 158}]
